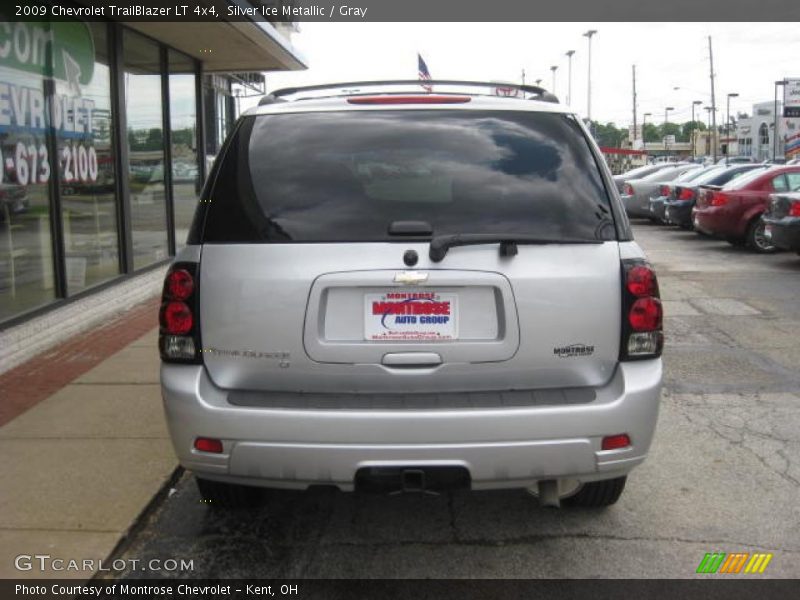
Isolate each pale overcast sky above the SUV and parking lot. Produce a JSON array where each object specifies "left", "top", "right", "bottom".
[{"left": 248, "top": 22, "right": 800, "bottom": 126}]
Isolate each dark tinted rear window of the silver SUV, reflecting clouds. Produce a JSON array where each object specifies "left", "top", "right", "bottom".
[{"left": 202, "top": 110, "right": 616, "bottom": 242}]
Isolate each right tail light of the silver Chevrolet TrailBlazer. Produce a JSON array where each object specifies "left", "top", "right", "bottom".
[{"left": 619, "top": 258, "right": 664, "bottom": 360}]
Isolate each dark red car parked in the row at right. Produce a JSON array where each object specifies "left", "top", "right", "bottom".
[{"left": 692, "top": 165, "right": 800, "bottom": 252}]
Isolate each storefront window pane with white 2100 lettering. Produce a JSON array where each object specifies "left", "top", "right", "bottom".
[{"left": 56, "top": 23, "right": 119, "bottom": 294}]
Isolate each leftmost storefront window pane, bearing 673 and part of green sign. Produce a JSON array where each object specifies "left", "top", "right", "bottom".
[{"left": 0, "top": 22, "right": 57, "bottom": 319}]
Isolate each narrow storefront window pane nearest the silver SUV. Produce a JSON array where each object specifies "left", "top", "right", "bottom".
[{"left": 169, "top": 50, "right": 202, "bottom": 250}]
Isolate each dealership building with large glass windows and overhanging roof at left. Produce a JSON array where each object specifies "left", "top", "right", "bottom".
[{"left": 0, "top": 7, "right": 306, "bottom": 372}]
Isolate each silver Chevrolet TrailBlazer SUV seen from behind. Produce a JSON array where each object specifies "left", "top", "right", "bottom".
[{"left": 159, "top": 81, "right": 663, "bottom": 506}]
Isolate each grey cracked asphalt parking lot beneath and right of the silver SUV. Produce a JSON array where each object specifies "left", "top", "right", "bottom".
[{"left": 112, "top": 222, "right": 800, "bottom": 578}]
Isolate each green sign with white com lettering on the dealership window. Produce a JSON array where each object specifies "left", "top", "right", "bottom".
[{"left": 0, "top": 15, "right": 94, "bottom": 90}]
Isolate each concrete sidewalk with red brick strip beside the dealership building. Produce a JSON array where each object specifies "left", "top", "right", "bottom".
[{"left": 0, "top": 299, "right": 177, "bottom": 579}]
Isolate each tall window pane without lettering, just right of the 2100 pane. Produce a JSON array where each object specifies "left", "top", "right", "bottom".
[{"left": 122, "top": 29, "right": 169, "bottom": 269}]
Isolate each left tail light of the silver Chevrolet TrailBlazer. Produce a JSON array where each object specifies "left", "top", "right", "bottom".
[{"left": 158, "top": 263, "right": 202, "bottom": 364}]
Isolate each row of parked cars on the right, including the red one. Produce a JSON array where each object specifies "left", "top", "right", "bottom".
[{"left": 614, "top": 161, "right": 800, "bottom": 254}]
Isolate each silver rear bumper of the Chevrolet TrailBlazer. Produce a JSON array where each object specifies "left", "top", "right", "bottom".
[{"left": 161, "top": 359, "right": 662, "bottom": 490}]
